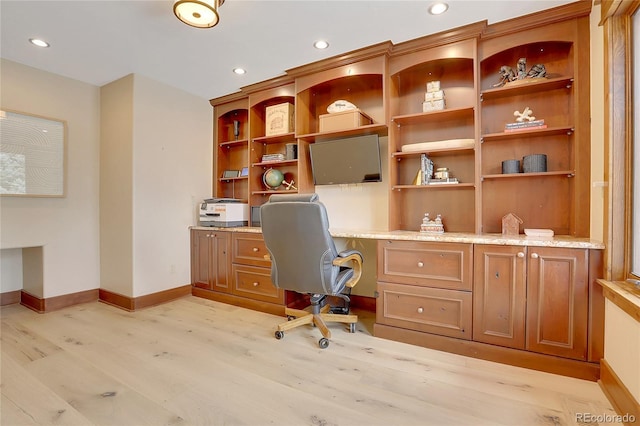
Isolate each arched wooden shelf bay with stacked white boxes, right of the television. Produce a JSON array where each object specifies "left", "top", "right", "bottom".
[{"left": 389, "top": 33, "right": 479, "bottom": 232}]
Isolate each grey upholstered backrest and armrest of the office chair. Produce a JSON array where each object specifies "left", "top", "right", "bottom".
[{"left": 260, "top": 194, "right": 353, "bottom": 295}]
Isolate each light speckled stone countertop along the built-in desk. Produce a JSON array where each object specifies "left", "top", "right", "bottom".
[{"left": 191, "top": 226, "right": 605, "bottom": 250}]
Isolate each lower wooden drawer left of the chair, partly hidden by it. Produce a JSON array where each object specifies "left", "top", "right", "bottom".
[{"left": 232, "top": 264, "right": 284, "bottom": 304}]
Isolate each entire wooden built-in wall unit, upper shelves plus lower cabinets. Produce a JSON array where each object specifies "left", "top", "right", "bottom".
[{"left": 202, "top": 1, "right": 602, "bottom": 379}]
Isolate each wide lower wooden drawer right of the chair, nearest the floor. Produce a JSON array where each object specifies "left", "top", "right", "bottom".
[{"left": 376, "top": 283, "right": 472, "bottom": 340}]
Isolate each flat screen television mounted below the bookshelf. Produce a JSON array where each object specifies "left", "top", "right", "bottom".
[{"left": 309, "top": 135, "right": 382, "bottom": 185}]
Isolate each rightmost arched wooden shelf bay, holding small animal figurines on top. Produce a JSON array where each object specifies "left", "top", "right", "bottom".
[{"left": 479, "top": 20, "right": 590, "bottom": 237}]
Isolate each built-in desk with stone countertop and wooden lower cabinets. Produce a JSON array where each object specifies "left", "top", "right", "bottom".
[{"left": 191, "top": 227, "right": 604, "bottom": 380}]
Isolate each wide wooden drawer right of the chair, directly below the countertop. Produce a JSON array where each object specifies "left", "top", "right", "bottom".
[{"left": 378, "top": 240, "right": 473, "bottom": 290}]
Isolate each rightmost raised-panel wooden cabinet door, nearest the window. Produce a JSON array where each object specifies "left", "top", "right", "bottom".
[{"left": 527, "top": 247, "right": 589, "bottom": 360}]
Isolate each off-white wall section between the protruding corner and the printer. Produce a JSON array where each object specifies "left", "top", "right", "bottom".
[{"left": 132, "top": 75, "right": 213, "bottom": 297}]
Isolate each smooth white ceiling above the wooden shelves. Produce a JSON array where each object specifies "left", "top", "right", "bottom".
[{"left": 0, "top": 0, "right": 571, "bottom": 99}]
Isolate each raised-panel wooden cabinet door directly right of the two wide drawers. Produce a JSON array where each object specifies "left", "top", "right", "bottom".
[{"left": 473, "top": 245, "right": 527, "bottom": 349}]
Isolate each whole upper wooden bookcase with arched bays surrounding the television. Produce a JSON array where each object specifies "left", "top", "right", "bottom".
[{"left": 212, "top": 3, "right": 590, "bottom": 237}]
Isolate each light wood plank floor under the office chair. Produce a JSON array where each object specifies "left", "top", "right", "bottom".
[{"left": 0, "top": 296, "right": 615, "bottom": 426}]
